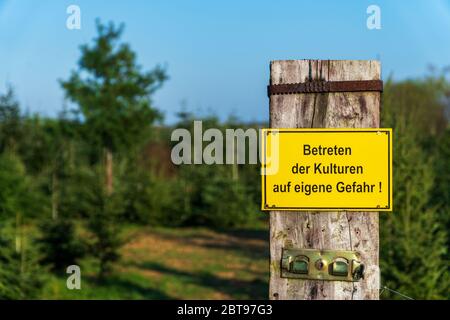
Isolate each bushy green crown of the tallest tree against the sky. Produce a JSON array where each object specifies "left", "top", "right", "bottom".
[{"left": 61, "top": 22, "right": 167, "bottom": 152}]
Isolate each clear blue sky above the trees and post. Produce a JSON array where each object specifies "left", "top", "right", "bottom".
[{"left": 0, "top": 0, "right": 450, "bottom": 123}]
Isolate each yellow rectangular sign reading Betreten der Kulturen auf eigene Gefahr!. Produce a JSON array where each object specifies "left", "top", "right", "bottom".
[{"left": 261, "top": 129, "right": 392, "bottom": 211}]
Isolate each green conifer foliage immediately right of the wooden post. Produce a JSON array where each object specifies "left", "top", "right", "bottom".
[{"left": 380, "top": 79, "right": 450, "bottom": 299}]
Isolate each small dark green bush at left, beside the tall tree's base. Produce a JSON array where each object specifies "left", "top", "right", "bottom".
[{"left": 38, "top": 218, "right": 85, "bottom": 274}]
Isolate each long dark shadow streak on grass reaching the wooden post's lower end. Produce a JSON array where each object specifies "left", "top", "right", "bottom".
[{"left": 130, "top": 262, "right": 268, "bottom": 300}]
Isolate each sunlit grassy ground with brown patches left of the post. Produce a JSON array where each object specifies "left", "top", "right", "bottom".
[{"left": 43, "top": 226, "right": 269, "bottom": 299}]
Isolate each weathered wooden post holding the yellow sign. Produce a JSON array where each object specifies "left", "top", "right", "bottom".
[{"left": 270, "top": 60, "right": 381, "bottom": 300}]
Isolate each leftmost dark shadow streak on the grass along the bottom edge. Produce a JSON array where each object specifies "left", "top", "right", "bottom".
[{"left": 87, "top": 275, "right": 173, "bottom": 300}]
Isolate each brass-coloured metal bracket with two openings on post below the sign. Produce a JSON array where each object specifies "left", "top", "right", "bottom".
[{"left": 281, "top": 249, "right": 364, "bottom": 281}]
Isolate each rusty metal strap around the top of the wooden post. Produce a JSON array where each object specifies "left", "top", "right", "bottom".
[{"left": 267, "top": 80, "right": 383, "bottom": 96}]
